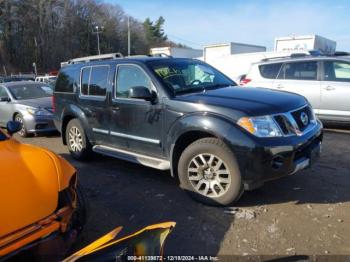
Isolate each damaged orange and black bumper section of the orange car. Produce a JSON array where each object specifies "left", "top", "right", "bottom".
[{"left": 0, "top": 182, "right": 82, "bottom": 261}]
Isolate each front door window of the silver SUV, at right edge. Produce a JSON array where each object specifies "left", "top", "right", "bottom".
[{"left": 324, "top": 61, "right": 350, "bottom": 82}]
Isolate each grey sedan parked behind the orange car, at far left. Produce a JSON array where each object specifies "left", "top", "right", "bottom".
[{"left": 0, "top": 81, "right": 56, "bottom": 137}]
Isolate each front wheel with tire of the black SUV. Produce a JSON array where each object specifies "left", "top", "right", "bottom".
[{"left": 178, "top": 137, "right": 244, "bottom": 206}]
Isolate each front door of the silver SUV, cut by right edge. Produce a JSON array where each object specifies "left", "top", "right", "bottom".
[{"left": 319, "top": 60, "right": 350, "bottom": 121}]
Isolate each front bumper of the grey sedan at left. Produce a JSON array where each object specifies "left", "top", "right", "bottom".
[{"left": 24, "top": 115, "right": 57, "bottom": 133}]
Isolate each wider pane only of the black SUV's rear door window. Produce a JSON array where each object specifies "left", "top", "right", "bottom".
[{"left": 89, "top": 66, "right": 109, "bottom": 96}]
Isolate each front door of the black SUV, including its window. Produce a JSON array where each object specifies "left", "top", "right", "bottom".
[{"left": 110, "top": 64, "right": 163, "bottom": 157}]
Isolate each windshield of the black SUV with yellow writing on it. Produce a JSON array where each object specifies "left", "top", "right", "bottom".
[{"left": 148, "top": 59, "right": 236, "bottom": 94}]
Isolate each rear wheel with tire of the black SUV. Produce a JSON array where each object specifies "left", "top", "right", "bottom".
[{"left": 65, "top": 119, "right": 92, "bottom": 160}]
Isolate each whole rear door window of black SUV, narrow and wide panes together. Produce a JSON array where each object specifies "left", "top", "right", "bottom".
[{"left": 80, "top": 65, "right": 109, "bottom": 96}]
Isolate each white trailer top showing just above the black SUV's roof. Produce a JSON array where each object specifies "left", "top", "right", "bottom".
[{"left": 150, "top": 46, "right": 203, "bottom": 58}]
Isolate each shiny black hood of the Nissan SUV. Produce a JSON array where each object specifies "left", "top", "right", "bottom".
[{"left": 175, "top": 86, "right": 307, "bottom": 116}]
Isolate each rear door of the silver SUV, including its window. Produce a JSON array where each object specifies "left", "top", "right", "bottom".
[{"left": 273, "top": 60, "right": 321, "bottom": 113}]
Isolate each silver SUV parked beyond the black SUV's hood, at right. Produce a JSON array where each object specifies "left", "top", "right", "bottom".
[{"left": 240, "top": 54, "right": 350, "bottom": 123}]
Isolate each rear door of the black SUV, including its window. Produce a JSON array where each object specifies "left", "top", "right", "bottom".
[{"left": 79, "top": 65, "right": 111, "bottom": 144}]
